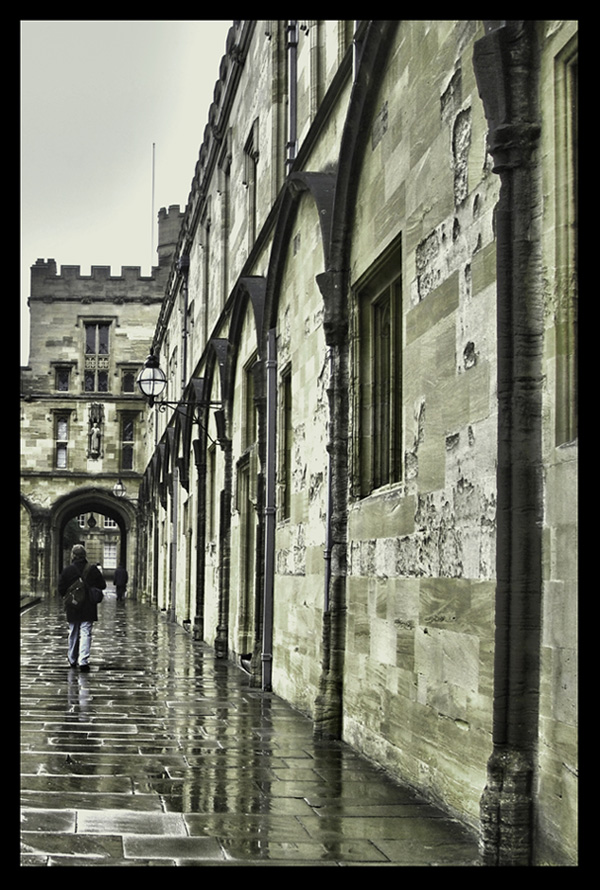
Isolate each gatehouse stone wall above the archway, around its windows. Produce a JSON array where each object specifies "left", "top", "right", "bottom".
[{"left": 21, "top": 260, "right": 161, "bottom": 489}]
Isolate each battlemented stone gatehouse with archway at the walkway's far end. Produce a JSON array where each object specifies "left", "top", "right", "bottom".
[{"left": 20, "top": 207, "right": 182, "bottom": 595}]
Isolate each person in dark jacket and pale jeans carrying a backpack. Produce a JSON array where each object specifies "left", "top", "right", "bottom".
[{"left": 58, "top": 544, "right": 106, "bottom": 671}]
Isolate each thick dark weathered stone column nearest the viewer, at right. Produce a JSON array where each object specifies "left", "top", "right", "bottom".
[{"left": 473, "top": 21, "right": 543, "bottom": 866}]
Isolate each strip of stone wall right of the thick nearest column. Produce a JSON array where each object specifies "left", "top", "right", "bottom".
[{"left": 536, "top": 21, "right": 578, "bottom": 864}]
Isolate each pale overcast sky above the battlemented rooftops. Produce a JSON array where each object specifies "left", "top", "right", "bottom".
[{"left": 21, "top": 20, "right": 232, "bottom": 364}]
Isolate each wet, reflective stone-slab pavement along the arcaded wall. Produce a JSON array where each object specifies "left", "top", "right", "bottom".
[{"left": 20, "top": 591, "right": 480, "bottom": 867}]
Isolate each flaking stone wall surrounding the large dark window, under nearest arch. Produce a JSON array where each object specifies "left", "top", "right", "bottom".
[{"left": 344, "top": 21, "right": 497, "bottom": 823}]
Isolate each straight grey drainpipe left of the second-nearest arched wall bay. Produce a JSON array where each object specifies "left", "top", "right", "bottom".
[{"left": 262, "top": 329, "right": 277, "bottom": 691}]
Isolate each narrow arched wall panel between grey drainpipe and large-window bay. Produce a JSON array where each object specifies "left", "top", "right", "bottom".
[{"left": 273, "top": 195, "right": 329, "bottom": 713}]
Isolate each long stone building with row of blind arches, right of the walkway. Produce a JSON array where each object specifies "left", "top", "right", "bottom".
[{"left": 21, "top": 21, "right": 577, "bottom": 865}]
